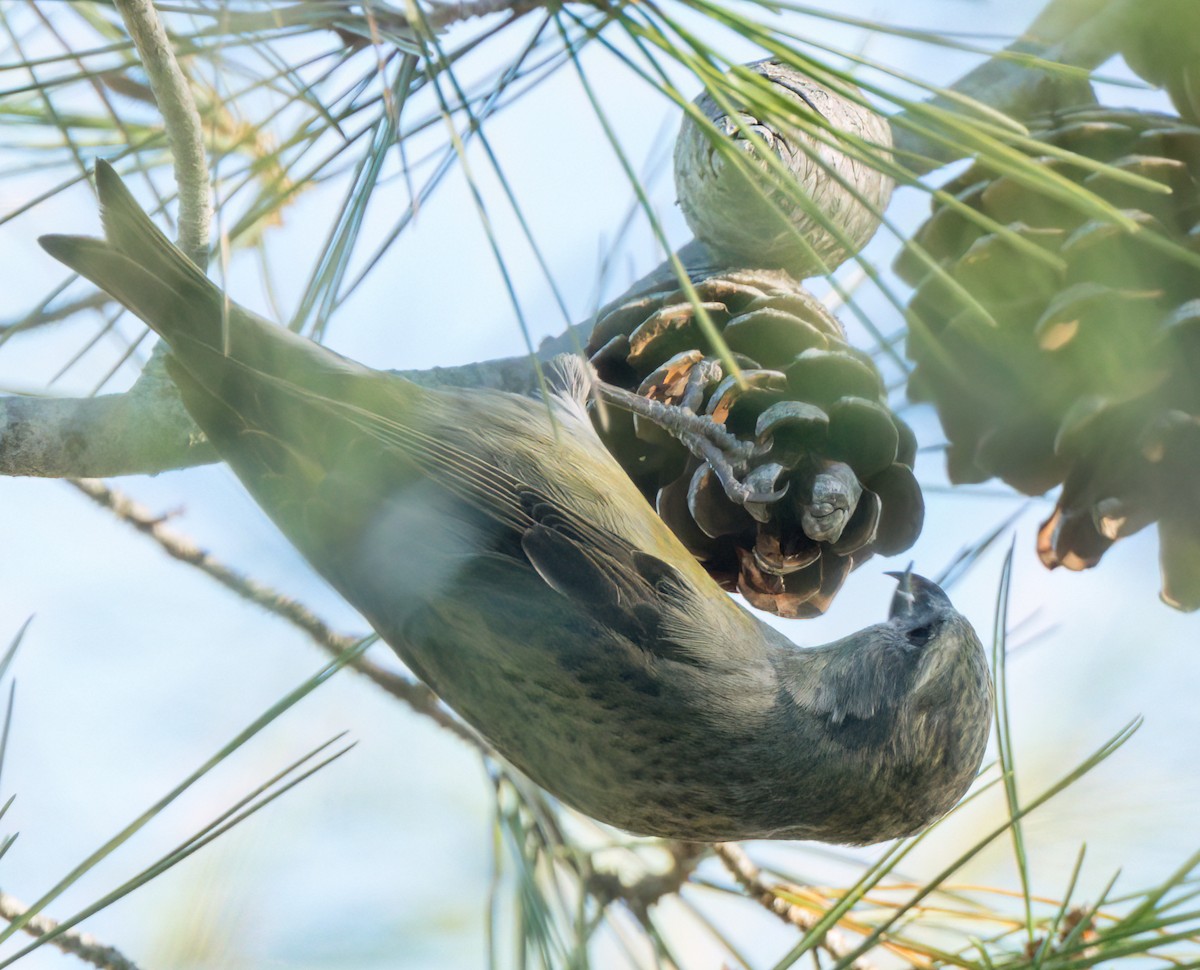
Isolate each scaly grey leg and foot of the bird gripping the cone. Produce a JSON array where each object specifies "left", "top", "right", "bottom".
[{"left": 594, "top": 381, "right": 787, "bottom": 505}]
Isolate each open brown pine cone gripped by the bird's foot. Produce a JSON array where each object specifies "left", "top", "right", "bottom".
[{"left": 588, "top": 270, "right": 924, "bottom": 617}]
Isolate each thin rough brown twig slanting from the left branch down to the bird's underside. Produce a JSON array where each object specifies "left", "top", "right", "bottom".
[{"left": 68, "top": 479, "right": 490, "bottom": 752}]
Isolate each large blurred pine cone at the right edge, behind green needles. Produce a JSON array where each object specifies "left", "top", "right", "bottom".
[{"left": 896, "top": 106, "right": 1200, "bottom": 610}]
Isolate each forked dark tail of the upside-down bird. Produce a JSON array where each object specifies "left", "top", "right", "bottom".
[{"left": 37, "top": 161, "right": 226, "bottom": 349}]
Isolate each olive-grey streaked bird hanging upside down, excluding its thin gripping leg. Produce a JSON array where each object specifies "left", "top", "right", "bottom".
[{"left": 38, "top": 161, "right": 992, "bottom": 844}]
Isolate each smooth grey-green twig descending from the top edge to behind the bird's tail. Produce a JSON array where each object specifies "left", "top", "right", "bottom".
[{"left": 113, "top": 0, "right": 212, "bottom": 269}]
